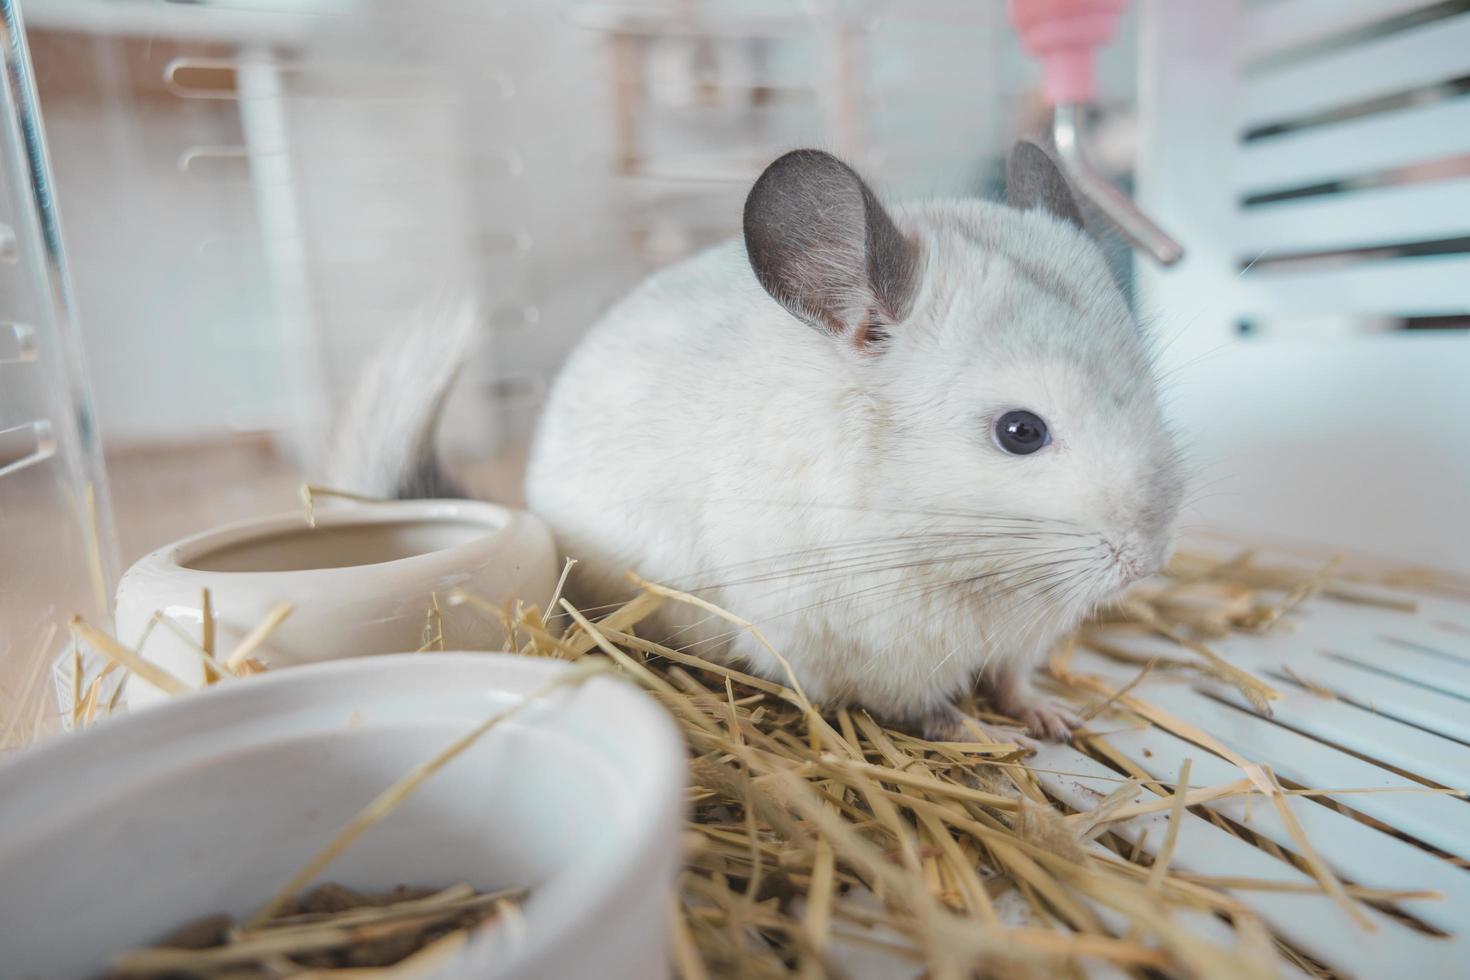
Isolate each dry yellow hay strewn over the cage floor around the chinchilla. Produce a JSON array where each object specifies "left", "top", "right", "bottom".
[{"left": 63, "top": 502, "right": 1464, "bottom": 980}]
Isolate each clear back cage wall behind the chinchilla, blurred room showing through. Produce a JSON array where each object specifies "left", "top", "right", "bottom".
[{"left": 28, "top": 0, "right": 1132, "bottom": 463}]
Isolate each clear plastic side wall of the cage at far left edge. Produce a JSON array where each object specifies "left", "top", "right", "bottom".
[{"left": 0, "top": 0, "right": 116, "bottom": 749}]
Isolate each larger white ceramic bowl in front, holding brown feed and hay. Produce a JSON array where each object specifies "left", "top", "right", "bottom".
[{"left": 0, "top": 654, "right": 684, "bottom": 980}]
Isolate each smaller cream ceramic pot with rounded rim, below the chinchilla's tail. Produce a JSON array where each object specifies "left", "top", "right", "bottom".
[{"left": 118, "top": 500, "right": 559, "bottom": 707}]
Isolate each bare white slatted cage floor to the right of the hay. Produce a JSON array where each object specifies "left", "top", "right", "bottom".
[{"left": 1029, "top": 555, "right": 1470, "bottom": 977}]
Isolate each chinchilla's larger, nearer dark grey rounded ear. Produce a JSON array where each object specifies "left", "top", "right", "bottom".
[{"left": 745, "top": 150, "right": 919, "bottom": 350}]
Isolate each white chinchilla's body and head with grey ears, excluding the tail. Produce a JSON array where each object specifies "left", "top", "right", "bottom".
[{"left": 330, "top": 144, "right": 1182, "bottom": 738}]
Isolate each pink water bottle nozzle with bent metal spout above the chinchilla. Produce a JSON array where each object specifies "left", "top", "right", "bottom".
[{"left": 1008, "top": 0, "right": 1185, "bottom": 266}]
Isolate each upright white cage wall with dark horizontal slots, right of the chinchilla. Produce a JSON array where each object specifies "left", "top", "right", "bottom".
[{"left": 1136, "top": 0, "right": 1470, "bottom": 578}]
